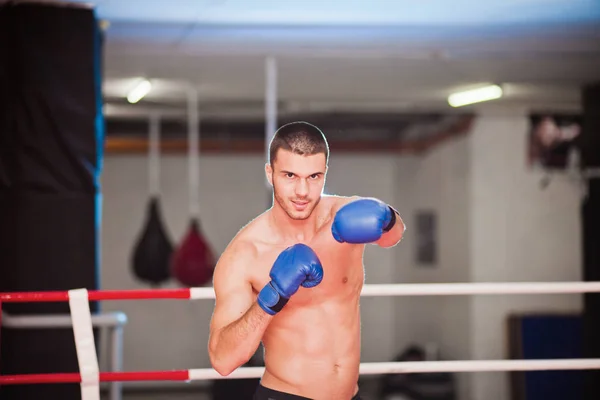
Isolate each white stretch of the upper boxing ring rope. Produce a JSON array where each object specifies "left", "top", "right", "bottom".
[{"left": 190, "top": 282, "right": 600, "bottom": 300}]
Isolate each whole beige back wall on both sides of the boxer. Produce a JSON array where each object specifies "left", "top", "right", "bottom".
[{"left": 102, "top": 113, "right": 581, "bottom": 400}]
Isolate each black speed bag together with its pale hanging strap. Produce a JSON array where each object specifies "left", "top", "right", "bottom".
[{"left": 131, "top": 115, "right": 173, "bottom": 287}]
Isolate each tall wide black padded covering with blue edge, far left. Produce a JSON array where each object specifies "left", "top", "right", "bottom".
[{"left": 0, "top": 2, "right": 104, "bottom": 400}]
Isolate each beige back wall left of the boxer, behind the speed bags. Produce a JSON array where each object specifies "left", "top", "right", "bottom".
[{"left": 101, "top": 155, "right": 266, "bottom": 370}]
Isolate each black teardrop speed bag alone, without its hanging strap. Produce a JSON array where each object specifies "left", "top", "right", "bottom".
[{"left": 131, "top": 197, "right": 173, "bottom": 286}]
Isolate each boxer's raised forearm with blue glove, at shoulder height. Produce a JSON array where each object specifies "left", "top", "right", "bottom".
[{"left": 331, "top": 197, "right": 406, "bottom": 247}]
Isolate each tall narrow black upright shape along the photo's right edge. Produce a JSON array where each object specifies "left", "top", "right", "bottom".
[{"left": 580, "top": 82, "right": 600, "bottom": 400}]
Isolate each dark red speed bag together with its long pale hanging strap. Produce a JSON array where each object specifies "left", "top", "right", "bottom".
[{"left": 171, "top": 89, "right": 216, "bottom": 286}]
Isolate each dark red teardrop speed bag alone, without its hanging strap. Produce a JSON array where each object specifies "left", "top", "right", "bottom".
[{"left": 171, "top": 218, "right": 216, "bottom": 287}]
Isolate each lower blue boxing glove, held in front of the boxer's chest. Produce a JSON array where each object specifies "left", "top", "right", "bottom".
[{"left": 257, "top": 243, "right": 323, "bottom": 315}]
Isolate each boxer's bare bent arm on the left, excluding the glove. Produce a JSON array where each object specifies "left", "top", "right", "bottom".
[{"left": 208, "top": 242, "right": 273, "bottom": 376}]
